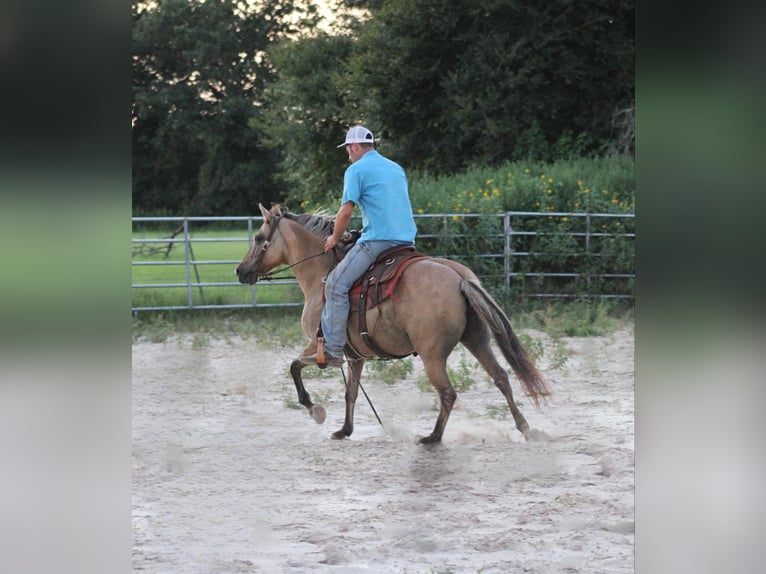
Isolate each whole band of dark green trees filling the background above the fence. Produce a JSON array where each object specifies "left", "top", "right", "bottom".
[{"left": 131, "top": 0, "right": 634, "bottom": 215}]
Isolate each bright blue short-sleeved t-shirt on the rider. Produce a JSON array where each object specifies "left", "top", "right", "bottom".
[{"left": 341, "top": 149, "right": 417, "bottom": 243}]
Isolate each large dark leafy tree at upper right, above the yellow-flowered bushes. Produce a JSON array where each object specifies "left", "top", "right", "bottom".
[{"left": 347, "top": 0, "right": 634, "bottom": 173}]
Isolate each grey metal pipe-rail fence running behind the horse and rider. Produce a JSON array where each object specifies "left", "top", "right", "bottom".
[{"left": 132, "top": 211, "right": 635, "bottom": 312}]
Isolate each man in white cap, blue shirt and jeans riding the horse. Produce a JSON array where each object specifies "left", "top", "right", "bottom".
[{"left": 302, "top": 126, "right": 417, "bottom": 366}]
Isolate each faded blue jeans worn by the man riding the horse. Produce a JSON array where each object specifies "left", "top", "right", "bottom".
[{"left": 322, "top": 241, "right": 411, "bottom": 357}]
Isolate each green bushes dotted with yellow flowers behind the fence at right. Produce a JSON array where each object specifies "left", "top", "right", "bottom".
[{"left": 410, "top": 156, "right": 635, "bottom": 296}]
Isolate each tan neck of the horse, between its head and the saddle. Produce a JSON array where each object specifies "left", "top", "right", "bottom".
[{"left": 285, "top": 223, "right": 331, "bottom": 301}]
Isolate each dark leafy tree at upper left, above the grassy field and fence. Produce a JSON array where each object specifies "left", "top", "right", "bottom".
[{"left": 132, "top": 0, "right": 315, "bottom": 215}]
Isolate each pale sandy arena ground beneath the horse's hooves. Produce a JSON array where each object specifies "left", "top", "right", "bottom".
[{"left": 133, "top": 325, "right": 634, "bottom": 574}]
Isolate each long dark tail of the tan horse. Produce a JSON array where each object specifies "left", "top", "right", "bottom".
[{"left": 460, "top": 279, "right": 551, "bottom": 408}]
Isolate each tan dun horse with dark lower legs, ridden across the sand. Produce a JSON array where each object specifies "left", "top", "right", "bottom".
[{"left": 236, "top": 204, "right": 550, "bottom": 444}]
